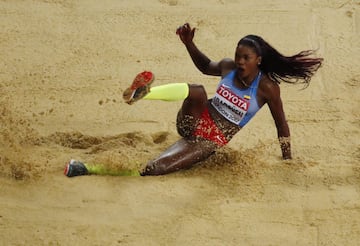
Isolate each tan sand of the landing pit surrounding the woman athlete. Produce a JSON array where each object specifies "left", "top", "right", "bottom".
[{"left": 0, "top": 0, "right": 360, "bottom": 246}]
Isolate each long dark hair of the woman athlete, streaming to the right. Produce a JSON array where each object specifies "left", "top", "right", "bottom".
[{"left": 238, "top": 35, "right": 323, "bottom": 87}]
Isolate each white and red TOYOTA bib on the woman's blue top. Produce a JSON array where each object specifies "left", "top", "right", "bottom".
[{"left": 211, "top": 85, "right": 250, "bottom": 125}]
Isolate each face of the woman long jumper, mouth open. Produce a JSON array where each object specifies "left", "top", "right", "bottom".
[{"left": 235, "top": 44, "right": 261, "bottom": 78}]
